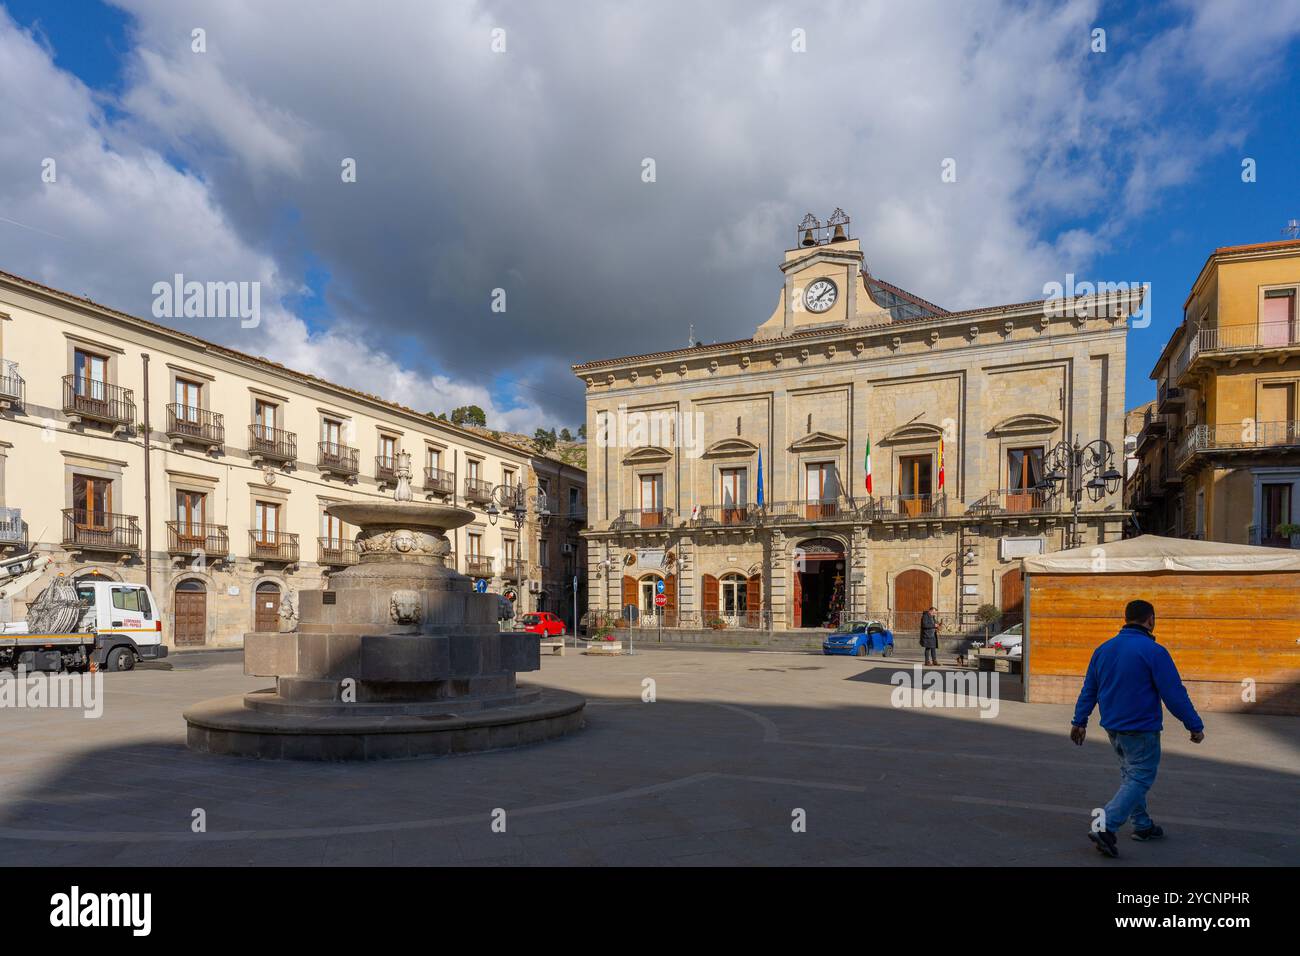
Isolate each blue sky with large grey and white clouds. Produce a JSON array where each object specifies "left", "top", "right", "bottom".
[{"left": 0, "top": 0, "right": 1300, "bottom": 433}]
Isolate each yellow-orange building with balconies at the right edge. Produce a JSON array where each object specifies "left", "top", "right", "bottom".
[{"left": 1128, "top": 241, "right": 1300, "bottom": 548}]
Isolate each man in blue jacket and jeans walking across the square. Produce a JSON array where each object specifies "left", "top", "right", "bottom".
[{"left": 1070, "top": 601, "right": 1205, "bottom": 857}]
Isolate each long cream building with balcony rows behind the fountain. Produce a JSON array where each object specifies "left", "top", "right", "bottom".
[{"left": 0, "top": 267, "right": 584, "bottom": 646}]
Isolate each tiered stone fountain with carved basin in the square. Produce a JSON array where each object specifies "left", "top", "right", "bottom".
[{"left": 185, "top": 453, "right": 586, "bottom": 760}]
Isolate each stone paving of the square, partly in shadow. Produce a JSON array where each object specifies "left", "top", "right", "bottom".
[{"left": 0, "top": 646, "right": 1300, "bottom": 866}]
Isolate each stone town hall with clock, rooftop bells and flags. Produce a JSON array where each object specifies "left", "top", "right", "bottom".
[{"left": 573, "top": 217, "right": 1141, "bottom": 635}]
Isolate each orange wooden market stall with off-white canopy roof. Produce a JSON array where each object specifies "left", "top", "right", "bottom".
[{"left": 1023, "top": 535, "right": 1300, "bottom": 714}]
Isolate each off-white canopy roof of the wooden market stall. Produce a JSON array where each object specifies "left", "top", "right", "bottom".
[{"left": 1024, "top": 535, "right": 1300, "bottom": 574}]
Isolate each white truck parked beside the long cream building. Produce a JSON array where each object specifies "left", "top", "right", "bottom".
[{"left": 0, "top": 553, "right": 166, "bottom": 671}]
